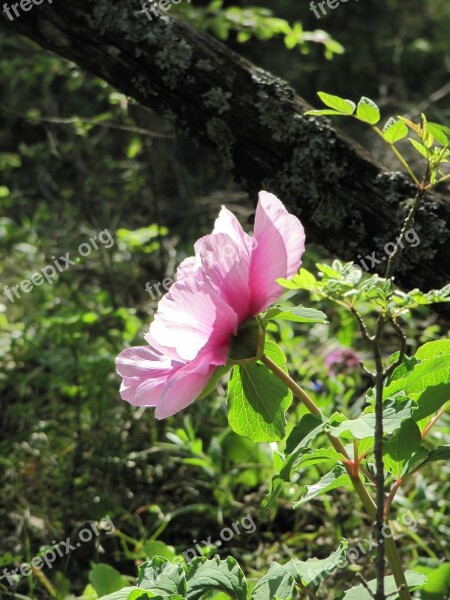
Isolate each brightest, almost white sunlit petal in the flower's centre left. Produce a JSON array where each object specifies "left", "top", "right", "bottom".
[{"left": 145, "top": 277, "right": 238, "bottom": 361}]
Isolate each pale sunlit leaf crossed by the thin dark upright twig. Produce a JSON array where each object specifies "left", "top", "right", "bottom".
[{"left": 329, "top": 400, "right": 412, "bottom": 440}]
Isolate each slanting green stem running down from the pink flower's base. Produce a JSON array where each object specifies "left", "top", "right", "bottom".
[{"left": 260, "top": 354, "right": 411, "bottom": 600}]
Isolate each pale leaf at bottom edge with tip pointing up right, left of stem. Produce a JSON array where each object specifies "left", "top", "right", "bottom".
[{"left": 285, "top": 539, "right": 348, "bottom": 590}]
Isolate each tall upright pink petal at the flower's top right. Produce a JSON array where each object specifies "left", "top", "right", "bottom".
[{"left": 249, "top": 192, "right": 305, "bottom": 315}]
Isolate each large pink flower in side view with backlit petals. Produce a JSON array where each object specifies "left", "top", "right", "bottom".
[{"left": 116, "top": 192, "right": 305, "bottom": 419}]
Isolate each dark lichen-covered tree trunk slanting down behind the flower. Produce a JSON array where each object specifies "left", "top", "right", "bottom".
[{"left": 0, "top": 0, "right": 450, "bottom": 304}]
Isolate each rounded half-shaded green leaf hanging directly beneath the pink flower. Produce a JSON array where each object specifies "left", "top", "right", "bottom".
[{"left": 228, "top": 362, "right": 292, "bottom": 442}]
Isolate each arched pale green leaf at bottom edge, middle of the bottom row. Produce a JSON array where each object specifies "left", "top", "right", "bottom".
[{"left": 186, "top": 556, "right": 247, "bottom": 600}]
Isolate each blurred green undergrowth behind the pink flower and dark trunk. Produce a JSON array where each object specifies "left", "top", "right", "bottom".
[{"left": 0, "top": 0, "right": 450, "bottom": 600}]
